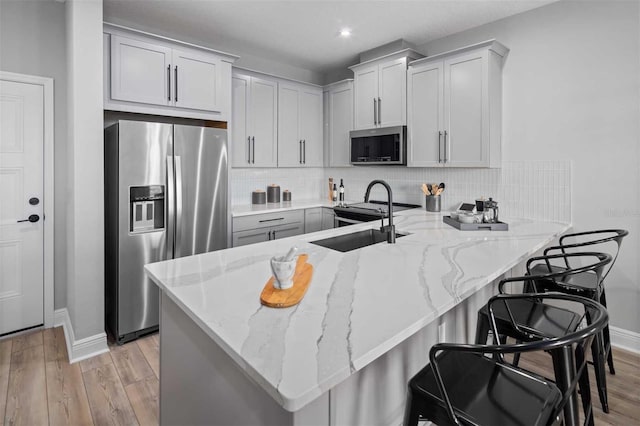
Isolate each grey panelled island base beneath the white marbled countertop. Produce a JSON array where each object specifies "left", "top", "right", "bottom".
[{"left": 160, "top": 285, "right": 495, "bottom": 425}]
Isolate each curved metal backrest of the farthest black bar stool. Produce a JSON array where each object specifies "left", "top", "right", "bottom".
[{"left": 544, "top": 229, "right": 629, "bottom": 283}]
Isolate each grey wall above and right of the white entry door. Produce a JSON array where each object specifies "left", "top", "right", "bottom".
[{"left": 0, "top": 0, "right": 67, "bottom": 309}]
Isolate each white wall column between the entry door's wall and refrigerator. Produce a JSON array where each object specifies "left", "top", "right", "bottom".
[{"left": 65, "top": 0, "right": 106, "bottom": 342}]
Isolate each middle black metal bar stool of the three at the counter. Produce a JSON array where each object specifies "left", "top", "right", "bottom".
[{"left": 476, "top": 252, "right": 611, "bottom": 424}]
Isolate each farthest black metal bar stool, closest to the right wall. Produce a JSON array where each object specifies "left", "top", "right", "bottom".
[{"left": 531, "top": 229, "right": 629, "bottom": 380}]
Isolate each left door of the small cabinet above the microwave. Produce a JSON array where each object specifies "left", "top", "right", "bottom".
[{"left": 353, "top": 65, "right": 378, "bottom": 129}]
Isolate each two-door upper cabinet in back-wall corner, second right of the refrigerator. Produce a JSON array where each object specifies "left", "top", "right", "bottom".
[{"left": 278, "top": 82, "right": 323, "bottom": 167}]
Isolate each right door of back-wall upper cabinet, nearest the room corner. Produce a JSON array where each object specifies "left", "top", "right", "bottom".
[{"left": 299, "top": 87, "right": 323, "bottom": 167}]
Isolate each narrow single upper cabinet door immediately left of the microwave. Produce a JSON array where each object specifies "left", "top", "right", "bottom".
[{"left": 329, "top": 83, "right": 353, "bottom": 167}]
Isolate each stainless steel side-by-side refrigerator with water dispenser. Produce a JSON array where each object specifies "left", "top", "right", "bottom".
[{"left": 104, "top": 120, "right": 228, "bottom": 343}]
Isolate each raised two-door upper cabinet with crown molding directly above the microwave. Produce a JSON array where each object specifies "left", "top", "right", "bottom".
[{"left": 350, "top": 49, "right": 422, "bottom": 130}]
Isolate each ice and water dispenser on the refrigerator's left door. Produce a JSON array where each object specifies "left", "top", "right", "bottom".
[{"left": 129, "top": 185, "right": 164, "bottom": 233}]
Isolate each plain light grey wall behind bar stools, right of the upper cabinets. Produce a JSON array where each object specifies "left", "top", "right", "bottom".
[{"left": 420, "top": 1, "right": 640, "bottom": 332}]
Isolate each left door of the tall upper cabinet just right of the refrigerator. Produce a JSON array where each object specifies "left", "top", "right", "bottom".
[{"left": 231, "top": 74, "right": 252, "bottom": 167}]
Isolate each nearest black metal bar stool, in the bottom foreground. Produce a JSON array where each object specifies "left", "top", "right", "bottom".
[{"left": 404, "top": 293, "right": 608, "bottom": 426}]
